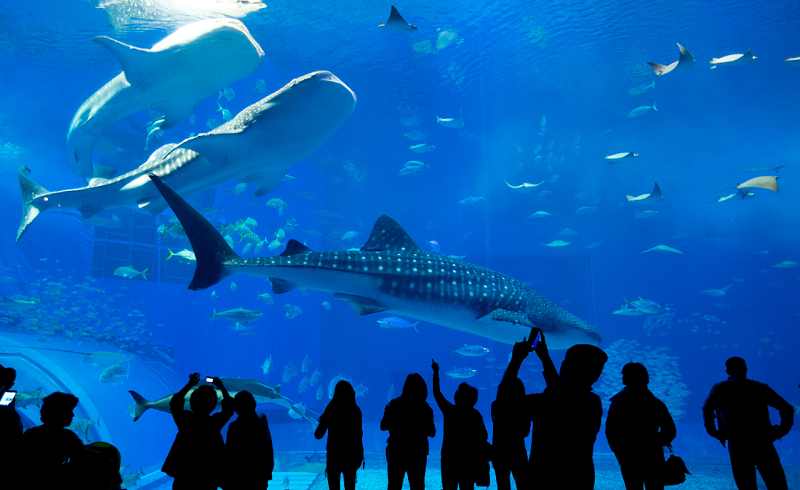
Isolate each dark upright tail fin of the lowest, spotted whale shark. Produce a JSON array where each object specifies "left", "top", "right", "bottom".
[{"left": 150, "top": 174, "right": 241, "bottom": 291}]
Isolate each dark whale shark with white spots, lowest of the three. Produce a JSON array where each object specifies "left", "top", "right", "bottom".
[{"left": 150, "top": 175, "right": 602, "bottom": 349}]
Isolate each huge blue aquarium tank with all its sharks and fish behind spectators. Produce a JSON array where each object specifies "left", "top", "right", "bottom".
[{"left": 0, "top": 0, "right": 800, "bottom": 489}]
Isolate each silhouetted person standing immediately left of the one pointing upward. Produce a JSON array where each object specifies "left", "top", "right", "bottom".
[{"left": 381, "top": 373, "right": 436, "bottom": 490}]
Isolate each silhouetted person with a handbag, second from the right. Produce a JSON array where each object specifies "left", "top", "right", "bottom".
[{"left": 606, "top": 362, "right": 675, "bottom": 490}]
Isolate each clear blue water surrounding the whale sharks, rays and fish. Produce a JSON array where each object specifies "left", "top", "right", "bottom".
[{"left": 0, "top": 0, "right": 800, "bottom": 486}]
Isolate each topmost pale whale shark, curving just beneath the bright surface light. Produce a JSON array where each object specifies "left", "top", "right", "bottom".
[{"left": 65, "top": 18, "right": 264, "bottom": 183}]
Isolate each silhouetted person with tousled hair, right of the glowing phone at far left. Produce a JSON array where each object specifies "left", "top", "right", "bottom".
[{"left": 21, "top": 391, "right": 84, "bottom": 488}]
